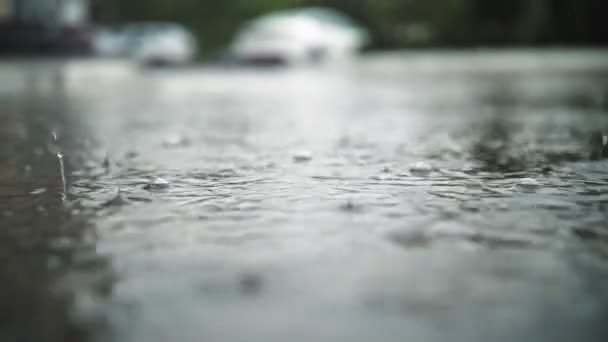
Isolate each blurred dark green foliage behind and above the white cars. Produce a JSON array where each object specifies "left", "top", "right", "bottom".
[{"left": 92, "top": 0, "right": 608, "bottom": 51}]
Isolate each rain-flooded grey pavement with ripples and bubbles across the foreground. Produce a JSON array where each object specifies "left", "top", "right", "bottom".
[{"left": 0, "top": 51, "right": 608, "bottom": 342}]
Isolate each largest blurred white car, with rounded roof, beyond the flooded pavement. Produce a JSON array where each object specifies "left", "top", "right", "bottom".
[{"left": 231, "top": 8, "right": 369, "bottom": 65}]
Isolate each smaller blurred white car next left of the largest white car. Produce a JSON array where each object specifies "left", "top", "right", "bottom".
[{"left": 123, "top": 22, "right": 196, "bottom": 65}]
